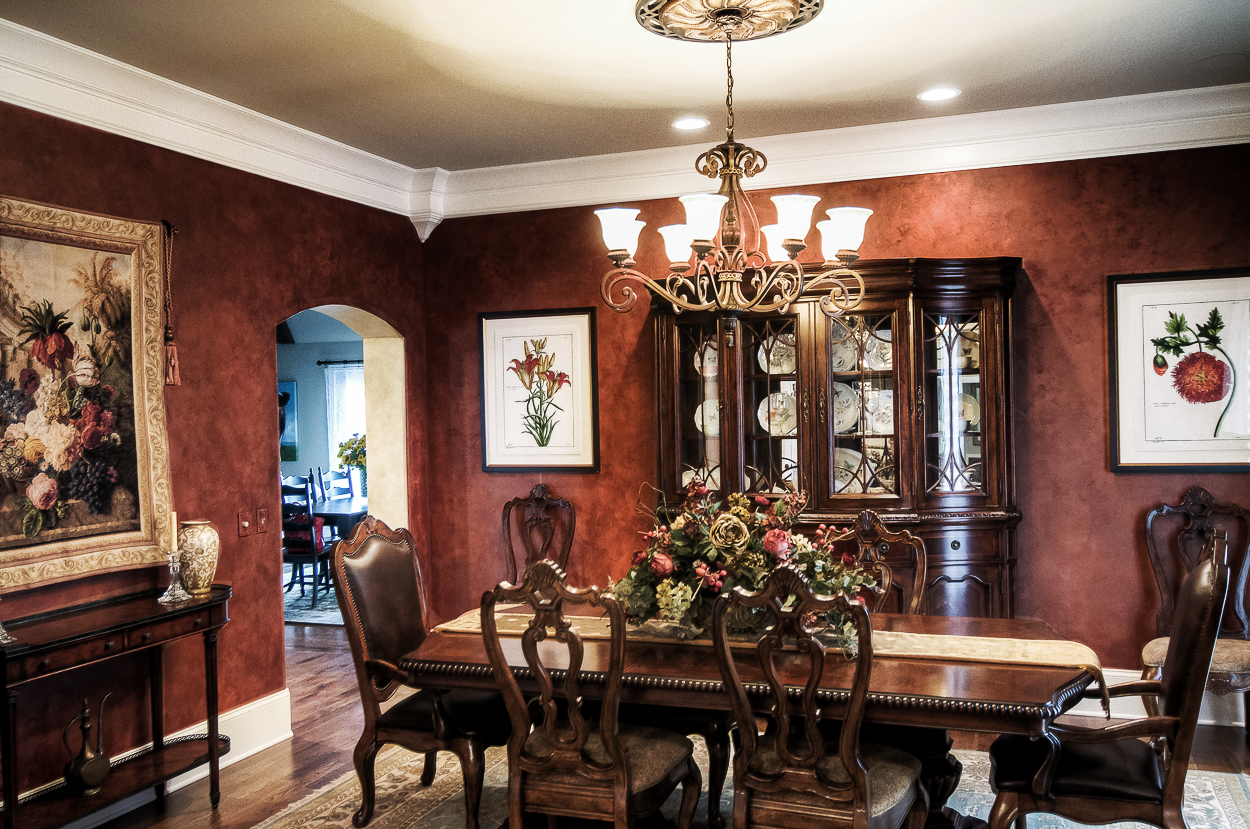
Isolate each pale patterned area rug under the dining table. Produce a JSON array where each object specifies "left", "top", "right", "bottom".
[{"left": 256, "top": 740, "right": 1250, "bottom": 829}]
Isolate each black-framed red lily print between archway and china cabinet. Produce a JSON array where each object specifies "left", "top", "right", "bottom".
[{"left": 478, "top": 308, "right": 599, "bottom": 473}]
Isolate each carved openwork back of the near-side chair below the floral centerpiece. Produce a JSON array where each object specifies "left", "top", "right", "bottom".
[{"left": 711, "top": 564, "right": 873, "bottom": 805}]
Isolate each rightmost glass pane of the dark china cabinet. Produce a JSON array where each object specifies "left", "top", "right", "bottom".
[{"left": 924, "top": 310, "right": 989, "bottom": 496}]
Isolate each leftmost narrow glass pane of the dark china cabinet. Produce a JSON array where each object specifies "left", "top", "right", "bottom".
[{"left": 676, "top": 321, "right": 724, "bottom": 489}]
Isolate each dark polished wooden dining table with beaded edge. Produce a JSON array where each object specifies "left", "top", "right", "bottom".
[{"left": 400, "top": 611, "right": 1098, "bottom": 829}]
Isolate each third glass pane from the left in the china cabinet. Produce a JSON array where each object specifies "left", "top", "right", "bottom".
[{"left": 816, "top": 308, "right": 908, "bottom": 509}]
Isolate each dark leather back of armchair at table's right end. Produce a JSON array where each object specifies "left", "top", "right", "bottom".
[{"left": 1159, "top": 529, "right": 1229, "bottom": 785}]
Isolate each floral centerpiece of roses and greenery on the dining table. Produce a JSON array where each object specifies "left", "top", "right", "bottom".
[{"left": 613, "top": 478, "right": 876, "bottom": 650}]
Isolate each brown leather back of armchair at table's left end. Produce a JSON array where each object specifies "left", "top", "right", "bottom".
[{"left": 331, "top": 515, "right": 426, "bottom": 704}]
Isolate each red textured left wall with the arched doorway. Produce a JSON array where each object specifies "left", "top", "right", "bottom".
[{"left": 0, "top": 104, "right": 426, "bottom": 784}]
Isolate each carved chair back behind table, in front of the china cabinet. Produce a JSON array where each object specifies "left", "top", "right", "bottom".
[{"left": 829, "top": 509, "right": 928, "bottom": 614}]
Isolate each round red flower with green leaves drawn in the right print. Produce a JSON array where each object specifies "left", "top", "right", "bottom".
[{"left": 1150, "top": 306, "right": 1238, "bottom": 438}]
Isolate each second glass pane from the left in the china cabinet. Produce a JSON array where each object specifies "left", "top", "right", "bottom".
[{"left": 738, "top": 316, "right": 804, "bottom": 494}]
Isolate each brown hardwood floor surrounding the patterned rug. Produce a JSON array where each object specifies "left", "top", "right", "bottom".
[{"left": 105, "top": 625, "right": 1250, "bottom": 829}]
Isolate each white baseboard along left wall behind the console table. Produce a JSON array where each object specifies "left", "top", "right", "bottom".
[{"left": 46, "top": 688, "right": 291, "bottom": 829}]
